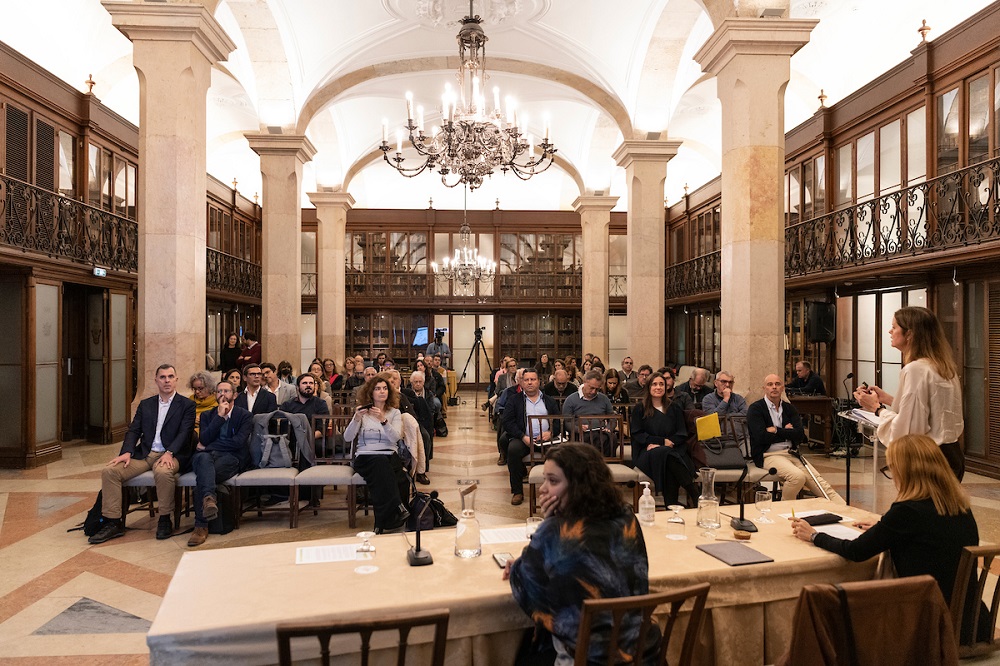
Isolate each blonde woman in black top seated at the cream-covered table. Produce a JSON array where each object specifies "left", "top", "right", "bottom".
[{"left": 792, "top": 435, "right": 990, "bottom": 642}]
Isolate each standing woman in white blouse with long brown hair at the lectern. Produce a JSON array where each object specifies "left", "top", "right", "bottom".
[{"left": 854, "top": 307, "right": 965, "bottom": 481}]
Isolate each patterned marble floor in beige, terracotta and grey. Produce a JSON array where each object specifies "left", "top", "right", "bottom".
[{"left": 0, "top": 394, "right": 1000, "bottom": 664}]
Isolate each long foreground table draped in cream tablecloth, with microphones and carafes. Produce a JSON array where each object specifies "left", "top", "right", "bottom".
[{"left": 146, "top": 500, "right": 875, "bottom": 666}]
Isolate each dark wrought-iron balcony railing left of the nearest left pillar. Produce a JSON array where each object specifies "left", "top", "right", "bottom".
[{"left": 0, "top": 176, "right": 139, "bottom": 273}]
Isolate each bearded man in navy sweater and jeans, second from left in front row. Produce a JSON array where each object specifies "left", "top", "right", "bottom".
[{"left": 188, "top": 378, "right": 252, "bottom": 548}]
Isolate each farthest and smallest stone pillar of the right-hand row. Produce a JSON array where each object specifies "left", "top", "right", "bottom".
[{"left": 573, "top": 196, "right": 618, "bottom": 362}]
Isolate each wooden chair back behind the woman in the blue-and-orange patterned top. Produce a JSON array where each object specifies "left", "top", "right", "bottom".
[{"left": 574, "top": 583, "right": 711, "bottom": 666}]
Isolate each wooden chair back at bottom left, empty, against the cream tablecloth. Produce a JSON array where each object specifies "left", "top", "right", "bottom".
[{"left": 277, "top": 608, "right": 449, "bottom": 666}]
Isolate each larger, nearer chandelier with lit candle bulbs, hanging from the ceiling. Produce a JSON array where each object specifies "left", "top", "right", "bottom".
[{"left": 381, "top": 0, "right": 557, "bottom": 190}]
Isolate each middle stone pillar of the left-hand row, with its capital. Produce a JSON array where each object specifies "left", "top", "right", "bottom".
[{"left": 245, "top": 133, "right": 316, "bottom": 372}]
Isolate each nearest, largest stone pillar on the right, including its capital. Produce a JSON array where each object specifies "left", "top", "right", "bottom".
[{"left": 695, "top": 18, "right": 817, "bottom": 399}]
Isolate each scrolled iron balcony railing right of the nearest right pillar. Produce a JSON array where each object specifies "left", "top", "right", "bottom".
[{"left": 785, "top": 158, "right": 1000, "bottom": 277}]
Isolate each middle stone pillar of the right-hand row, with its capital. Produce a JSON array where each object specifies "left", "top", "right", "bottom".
[{"left": 612, "top": 140, "right": 681, "bottom": 368}]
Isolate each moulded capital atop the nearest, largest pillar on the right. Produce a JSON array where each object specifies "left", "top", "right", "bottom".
[{"left": 694, "top": 18, "right": 819, "bottom": 75}]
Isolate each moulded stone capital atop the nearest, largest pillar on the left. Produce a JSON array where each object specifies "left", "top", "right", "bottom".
[{"left": 101, "top": 2, "right": 236, "bottom": 63}]
